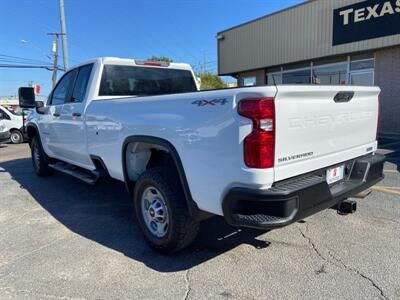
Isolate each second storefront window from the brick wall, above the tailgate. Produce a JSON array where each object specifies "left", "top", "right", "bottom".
[{"left": 313, "top": 62, "right": 347, "bottom": 85}]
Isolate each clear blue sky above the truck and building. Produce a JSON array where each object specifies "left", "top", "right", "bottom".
[{"left": 0, "top": 0, "right": 303, "bottom": 97}]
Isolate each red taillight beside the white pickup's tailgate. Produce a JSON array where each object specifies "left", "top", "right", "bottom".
[{"left": 239, "top": 98, "right": 275, "bottom": 169}]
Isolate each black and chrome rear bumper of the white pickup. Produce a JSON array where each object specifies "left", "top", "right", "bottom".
[{"left": 222, "top": 154, "right": 385, "bottom": 229}]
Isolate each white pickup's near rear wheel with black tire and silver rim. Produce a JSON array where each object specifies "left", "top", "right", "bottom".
[{"left": 134, "top": 167, "right": 199, "bottom": 253}]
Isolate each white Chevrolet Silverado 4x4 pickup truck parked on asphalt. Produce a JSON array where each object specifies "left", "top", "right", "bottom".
[{"left": 19, "top": 58, "right": 384, "bottom": 252}]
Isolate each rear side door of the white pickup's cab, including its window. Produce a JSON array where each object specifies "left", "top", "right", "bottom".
[{"left": 58, "top": 64, "right": 93, "bottom": 167}]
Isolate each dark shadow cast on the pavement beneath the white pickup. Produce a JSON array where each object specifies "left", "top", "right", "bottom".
[{"left": 0, "top": 158, "right": 269, "bottom": 272}]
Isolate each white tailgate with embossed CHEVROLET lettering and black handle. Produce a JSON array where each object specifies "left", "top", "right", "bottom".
[{"left": 274, "top": 85, "right": 380, "bottom": 181}]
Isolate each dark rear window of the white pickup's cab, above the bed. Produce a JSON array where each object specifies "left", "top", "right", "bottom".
[{"left": 99, "top": 65, "right": 197, "bottom": 96}]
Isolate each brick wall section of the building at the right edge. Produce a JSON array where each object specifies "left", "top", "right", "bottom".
[{"left": 375, "top": 47, "right": 400, "bottom": 135}]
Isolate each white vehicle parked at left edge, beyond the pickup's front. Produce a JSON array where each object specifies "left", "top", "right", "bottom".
[{"left": 0, "top": 105, "right": 26, "bottom": 144}]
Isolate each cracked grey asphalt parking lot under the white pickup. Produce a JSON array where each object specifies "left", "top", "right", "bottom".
[{"left": 0, "top": 140, "right": 400, "bottom": 299}]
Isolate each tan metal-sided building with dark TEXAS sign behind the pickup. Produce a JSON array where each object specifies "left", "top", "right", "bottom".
[{"left": 217, "top": 0, "right": 400, "bottom": 135}]
